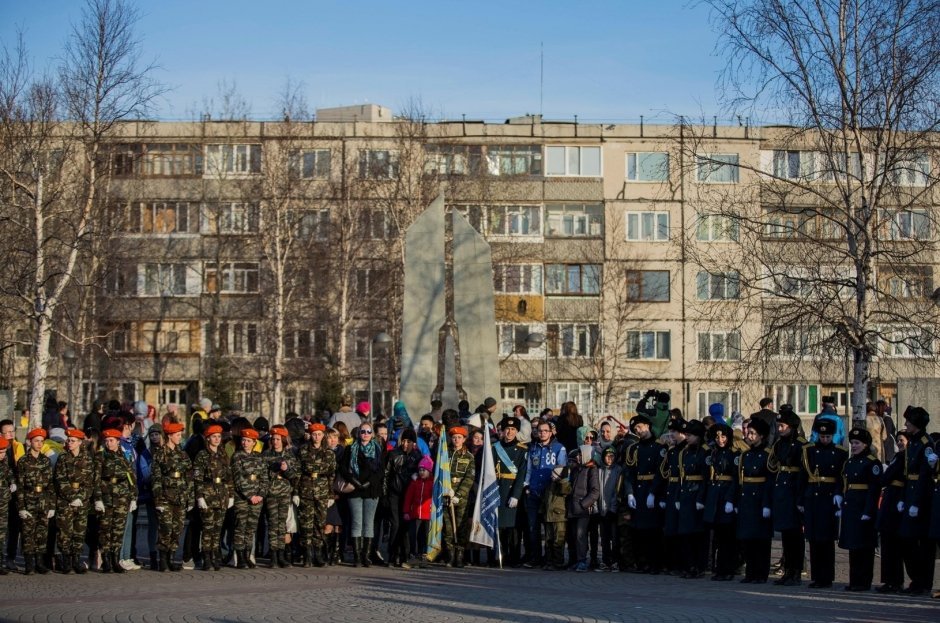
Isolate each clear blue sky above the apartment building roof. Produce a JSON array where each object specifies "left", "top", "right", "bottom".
[{"left": 0, "top": 0, "right": 723, "bottom": 122}]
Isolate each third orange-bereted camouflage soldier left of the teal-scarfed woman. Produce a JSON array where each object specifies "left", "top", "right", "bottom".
[{"left": 232, "top": 428, "right": 270, "bottom": 569}]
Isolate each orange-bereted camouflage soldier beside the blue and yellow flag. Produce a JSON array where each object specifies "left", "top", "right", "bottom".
[{"left": 444, "top": 426, "right": 474, "bottom": 568}]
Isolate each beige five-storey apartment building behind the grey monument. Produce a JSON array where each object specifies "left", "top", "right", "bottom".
[{"left": 7, "top": 106, "right": 937, "bottom": 426}]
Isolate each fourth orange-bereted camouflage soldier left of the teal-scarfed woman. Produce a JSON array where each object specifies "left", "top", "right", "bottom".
[{"left": 193, "top": 424, "right": 235, "bottom": 571}]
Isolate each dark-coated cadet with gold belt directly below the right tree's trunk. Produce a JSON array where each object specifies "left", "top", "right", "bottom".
[{"left": 839, "top": 428, "right": 881, "bottom": 591}]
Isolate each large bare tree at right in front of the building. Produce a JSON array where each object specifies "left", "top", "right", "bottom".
[{"left": 679, "top": 0, "right": 940, "bottom": 419}]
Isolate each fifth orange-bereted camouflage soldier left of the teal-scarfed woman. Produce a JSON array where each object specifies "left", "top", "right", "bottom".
[{"left": 151, "top": 422, "right": 193, "bottom": 571}]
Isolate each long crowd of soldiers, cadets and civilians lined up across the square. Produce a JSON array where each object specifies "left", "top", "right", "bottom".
[{"left": 0, "top": 391, "right": 940, "bottom": 598}]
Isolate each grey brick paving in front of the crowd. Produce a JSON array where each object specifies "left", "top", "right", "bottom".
[{"left": 0, "top": 556, "right": 940, "bottom": 623}]
